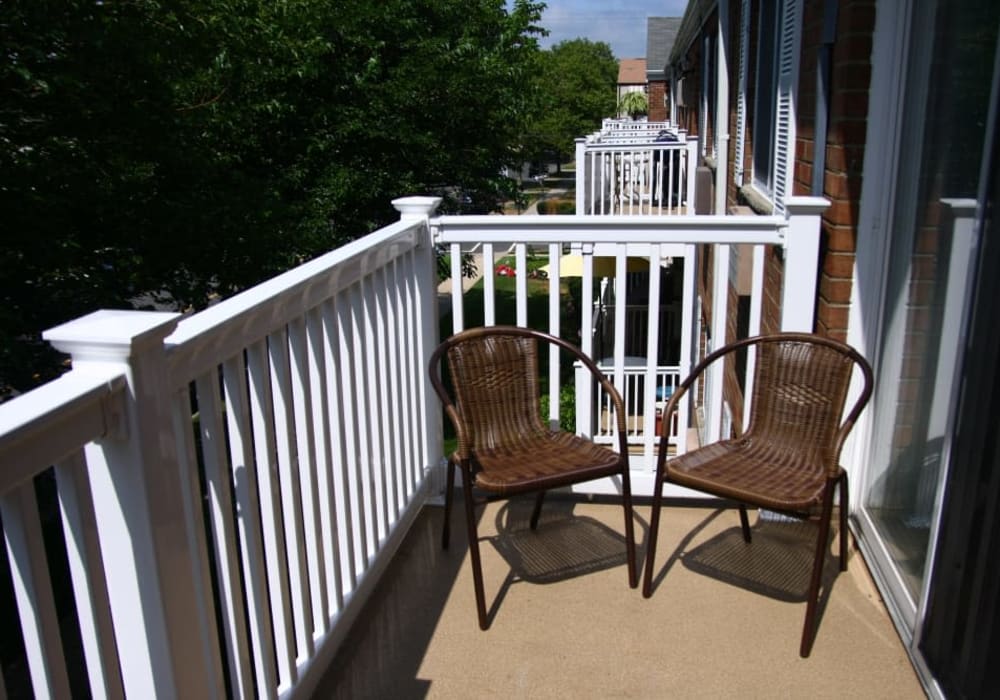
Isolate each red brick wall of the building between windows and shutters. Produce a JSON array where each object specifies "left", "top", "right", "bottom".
[{"left": 679, "top": 0, "right": 875, "bottom": 438}]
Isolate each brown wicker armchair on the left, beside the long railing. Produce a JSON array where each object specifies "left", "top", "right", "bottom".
[{"left": 430, "top": 326, "right": 639, "bottom": 630}]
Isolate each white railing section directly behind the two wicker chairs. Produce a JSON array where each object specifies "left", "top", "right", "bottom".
[{"left": 431, "top": 198, "right": 827, "bottom": 484}]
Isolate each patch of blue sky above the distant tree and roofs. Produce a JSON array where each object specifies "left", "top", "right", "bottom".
[{"left": 508, "top": 0, "right": 687, "bottom": 58}]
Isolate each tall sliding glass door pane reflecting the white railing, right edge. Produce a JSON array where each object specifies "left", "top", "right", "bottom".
[{"left": 862, "top": 0, "right": 1000, "bottom": 614}]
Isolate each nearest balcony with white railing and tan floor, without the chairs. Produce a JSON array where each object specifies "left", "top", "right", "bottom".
[{"left": 0, "top": 198, "right": 919, "bottom": 697}]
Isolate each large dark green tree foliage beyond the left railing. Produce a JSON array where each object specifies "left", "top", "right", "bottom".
[{"left": 0, "top": 0, "right": 543, "bottom": 393}]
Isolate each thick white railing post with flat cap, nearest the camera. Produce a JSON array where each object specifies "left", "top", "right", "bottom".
[{"left": 43, "top": 311, "right": 225, "bottom": 698}]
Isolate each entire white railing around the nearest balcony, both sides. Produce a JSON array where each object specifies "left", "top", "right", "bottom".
[{"left": 0, "top": 198, "right": 826, "bottom": 698}]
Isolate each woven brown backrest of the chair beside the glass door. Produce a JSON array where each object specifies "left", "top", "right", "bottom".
[{"left": 743, "top": 333, "right": 871, "bottom": 473}]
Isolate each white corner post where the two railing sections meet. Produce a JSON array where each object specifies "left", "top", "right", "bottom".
[{"left": 392, "top": 197, "right": 444, "bottom": 493}]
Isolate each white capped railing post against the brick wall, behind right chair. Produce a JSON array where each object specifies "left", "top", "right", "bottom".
[{"left": 781, "top": 197, "right": 830, "bottom": 333}]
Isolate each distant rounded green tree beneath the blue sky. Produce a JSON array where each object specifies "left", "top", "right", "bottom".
[{"left": 525, "top": 39, "right": 618, "bottom": 167}]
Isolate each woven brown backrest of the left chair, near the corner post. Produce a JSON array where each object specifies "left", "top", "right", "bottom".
[{"left": 432, "top": 327, "right": 547, "bottom": 452}]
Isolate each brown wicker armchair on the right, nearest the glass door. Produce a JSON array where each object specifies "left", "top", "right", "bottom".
[{"left": 642, "top": 333, "right": 872, "bottom": 657}]
